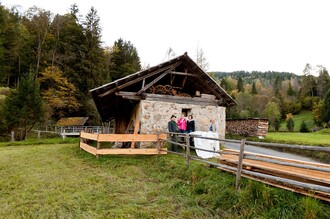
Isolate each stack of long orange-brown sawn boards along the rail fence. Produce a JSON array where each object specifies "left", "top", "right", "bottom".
[{"left": 219, "top": 150, "right": 330, "bottom": 202}]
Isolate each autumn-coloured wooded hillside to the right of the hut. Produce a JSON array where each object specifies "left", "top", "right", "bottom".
[{"left": 210, "top": 67, "right": 330, "bottom": 130}]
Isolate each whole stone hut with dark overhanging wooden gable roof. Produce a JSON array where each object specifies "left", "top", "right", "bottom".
[{"left": 90, "top": 53, "right": 236, "bottom": 140}]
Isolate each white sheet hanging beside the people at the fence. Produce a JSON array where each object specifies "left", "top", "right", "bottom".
[{"left": 190, "top": 131, "right": 220, "bottom": 158}]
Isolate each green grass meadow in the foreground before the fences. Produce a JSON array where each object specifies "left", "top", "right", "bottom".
[{"left": 0, "top": 143, "right": 330, "bottom": 218}]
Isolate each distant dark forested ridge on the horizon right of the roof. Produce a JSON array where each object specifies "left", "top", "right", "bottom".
[{"left": 212, "top": 71, "right": 300, "bottom": 83}]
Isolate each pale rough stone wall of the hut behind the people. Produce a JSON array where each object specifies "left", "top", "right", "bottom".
[{"left": 131, "top": 100, "right": 226, "bottom": 138}]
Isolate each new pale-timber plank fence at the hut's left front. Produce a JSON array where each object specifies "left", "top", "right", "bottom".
[{"left": 79, "top": 132, "right": 167, "bottom": 157}]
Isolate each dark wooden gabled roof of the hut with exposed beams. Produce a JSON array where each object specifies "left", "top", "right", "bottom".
[{"left": 90, "top": 53, "right": 236, "bottom": 121}]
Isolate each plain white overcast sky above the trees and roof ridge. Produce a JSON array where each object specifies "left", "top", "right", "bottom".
[{"left": 0, "top": 0, "right": 330, "bottom": 75}]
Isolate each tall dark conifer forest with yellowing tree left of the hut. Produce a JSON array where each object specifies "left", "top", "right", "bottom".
[{"left": 0, "top": 3, "right": 141, "bottom": 137}]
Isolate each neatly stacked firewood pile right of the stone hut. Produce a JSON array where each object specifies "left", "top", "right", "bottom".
[{"left": 226, "top": 119, "right": 268, "bottom": 137}]
